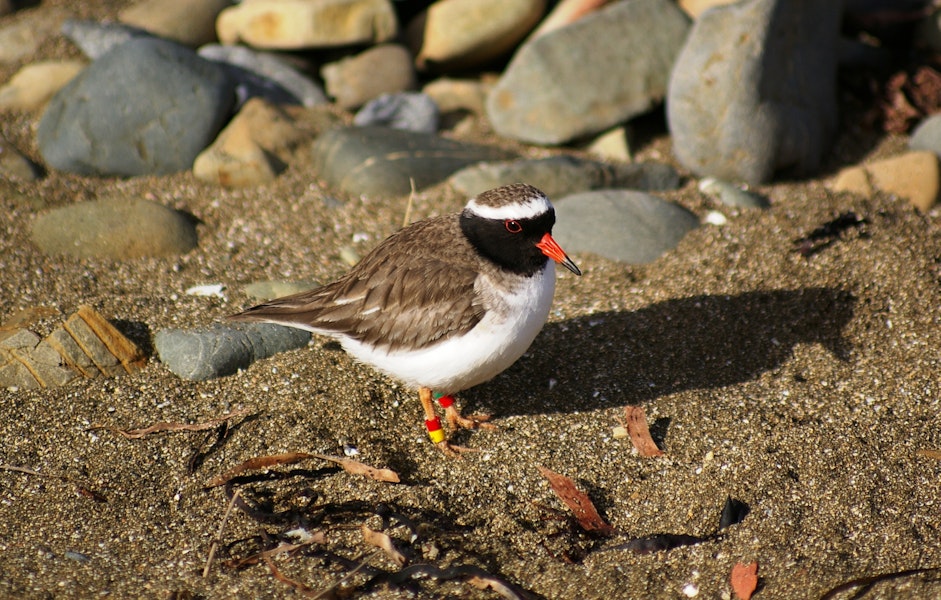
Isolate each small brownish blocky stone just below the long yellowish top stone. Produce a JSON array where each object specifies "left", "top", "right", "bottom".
[{"left": 320, "top": 44, "right": 416, "bottom": 110}]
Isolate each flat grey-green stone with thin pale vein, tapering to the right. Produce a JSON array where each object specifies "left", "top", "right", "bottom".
[{"left": 313, "top": 126, "right": 512, "bottom": 198}]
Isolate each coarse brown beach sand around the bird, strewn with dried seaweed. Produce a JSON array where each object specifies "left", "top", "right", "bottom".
[{"left": 0, "top": 2, "right": 941, "bottom": 599}]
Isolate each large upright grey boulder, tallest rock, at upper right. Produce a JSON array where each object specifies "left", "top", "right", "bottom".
[{"left": 667, "top": 0, "right": 842, "bottom": 184}]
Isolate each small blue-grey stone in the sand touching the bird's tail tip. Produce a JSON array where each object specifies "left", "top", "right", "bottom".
[{"left": 154, "top": 323, "right": 310, "bottom": 381}]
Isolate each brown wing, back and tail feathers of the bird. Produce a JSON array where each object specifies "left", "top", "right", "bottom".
[{"left": 230, "top": 217, "right": 485, "bottom": 349}]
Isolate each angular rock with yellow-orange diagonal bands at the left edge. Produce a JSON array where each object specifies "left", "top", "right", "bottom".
[{"left": 0, "top": 305, "right": 147, "bottom": 389}]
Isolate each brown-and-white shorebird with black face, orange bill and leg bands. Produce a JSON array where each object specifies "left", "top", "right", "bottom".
[{"left": 228, "top": 183, "right": 582, "bottom": 456}]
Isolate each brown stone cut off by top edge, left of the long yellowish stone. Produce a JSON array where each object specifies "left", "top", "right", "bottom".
[{"left": 118, "top": 0, "right": 232, "bottom": 48}]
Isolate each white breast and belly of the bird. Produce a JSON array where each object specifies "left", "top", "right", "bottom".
[{"left": 341, "top": 261, "right": 555, "bottom": 394}]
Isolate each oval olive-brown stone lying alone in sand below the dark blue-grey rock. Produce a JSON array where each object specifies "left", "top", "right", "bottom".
[{"left": 32, "top": 198, "right": 198, "bottom": 260}]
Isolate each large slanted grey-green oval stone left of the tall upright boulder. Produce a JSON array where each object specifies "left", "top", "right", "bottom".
[{"left": 487, "top": 0, "right": 689, "bottom": 144}]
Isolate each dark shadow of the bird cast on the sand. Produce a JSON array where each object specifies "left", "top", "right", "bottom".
[{"left": 462, "top": 287, "right": 856, "bottom": 416}]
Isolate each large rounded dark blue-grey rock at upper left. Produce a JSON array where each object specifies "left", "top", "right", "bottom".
[{"left": 37, "top": 38, "right": 235, "bottom": 176}]
